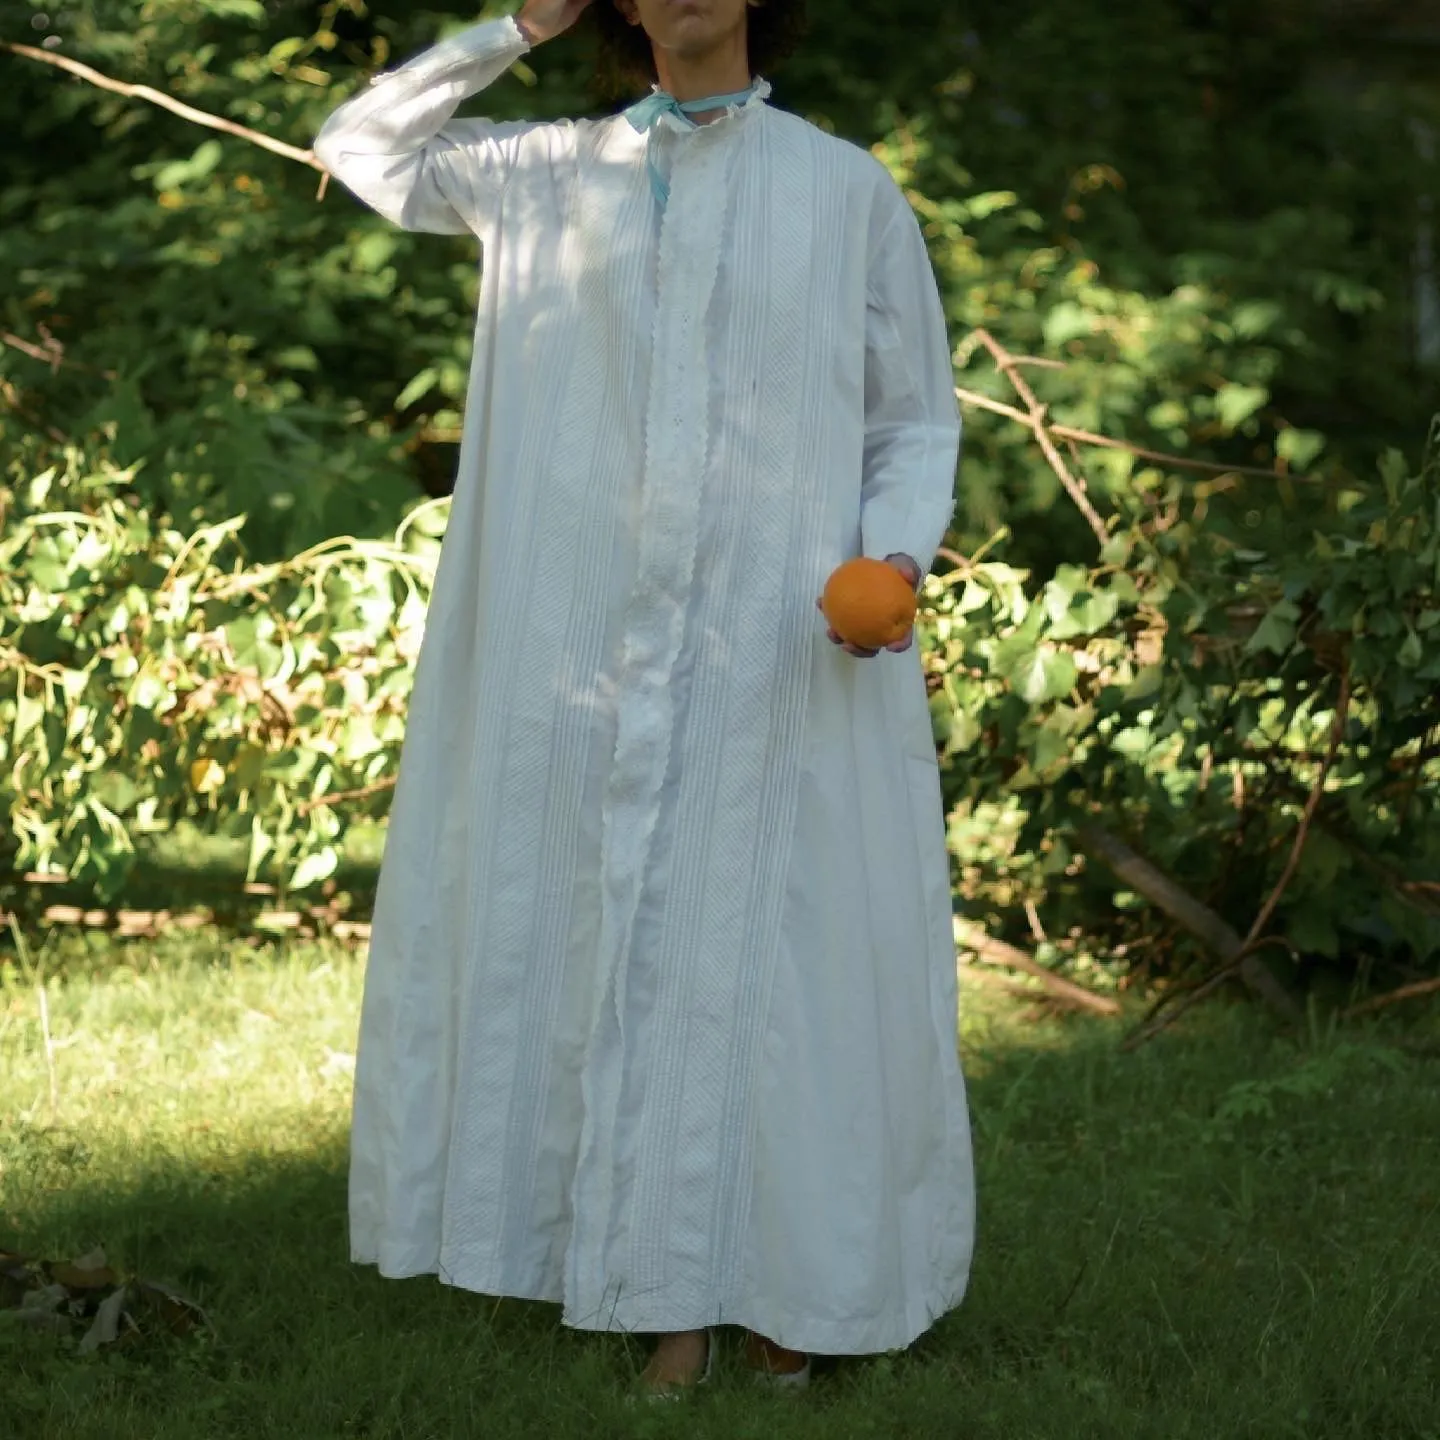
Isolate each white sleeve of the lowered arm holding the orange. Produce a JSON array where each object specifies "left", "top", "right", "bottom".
[{"left": 860, "top": 189, "right": 960, "bottom": 575}]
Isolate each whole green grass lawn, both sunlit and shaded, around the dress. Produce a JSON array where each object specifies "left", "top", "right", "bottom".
[{"left": 0, "top": 932, "right": 1440, "bottom": 1440}]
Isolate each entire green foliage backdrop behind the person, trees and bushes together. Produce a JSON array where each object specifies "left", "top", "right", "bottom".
[{"left": 0, "top": 0, "right": 1440, "bottom": 990}]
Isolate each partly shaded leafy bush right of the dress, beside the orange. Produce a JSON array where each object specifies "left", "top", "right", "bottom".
[{"left": 923, "top": 420, "right": 1440, "bottom": 963}]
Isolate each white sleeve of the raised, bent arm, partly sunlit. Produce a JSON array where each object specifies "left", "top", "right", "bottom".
[{"left": 315, "top": 19, "right": 550, "bottom": 235}]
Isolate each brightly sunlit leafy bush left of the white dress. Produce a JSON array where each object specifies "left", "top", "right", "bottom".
[{"left": 0, "top": 432, "right": 448, "bottom": 897}]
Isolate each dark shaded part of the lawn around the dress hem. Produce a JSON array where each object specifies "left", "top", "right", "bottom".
[{"left": 0, "top": 1011, "right": 1440, "bottom": 1440}]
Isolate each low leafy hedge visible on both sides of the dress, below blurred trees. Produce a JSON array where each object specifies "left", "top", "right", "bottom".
[{"left": 0, "top": 422, "right": 1440, "bottom": 1002}]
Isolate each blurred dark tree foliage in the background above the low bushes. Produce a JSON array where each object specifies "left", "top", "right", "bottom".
[{"left": 0, "top": 0, "right": 1440, "bottom": 558}]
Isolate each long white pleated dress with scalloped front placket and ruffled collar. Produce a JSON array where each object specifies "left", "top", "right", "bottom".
[{"left": 315, "top": 20, "right": 975, "bottom": 1354}]
